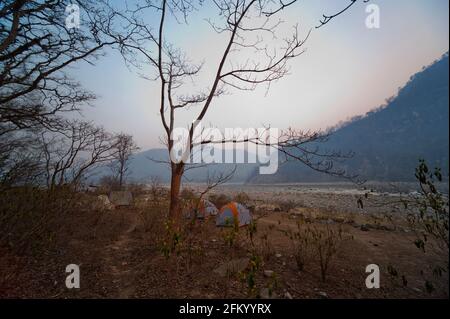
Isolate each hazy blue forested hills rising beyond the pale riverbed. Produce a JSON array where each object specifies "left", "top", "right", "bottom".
[{"left": 118, "top": 53, "right": 449, "bottom": 183}]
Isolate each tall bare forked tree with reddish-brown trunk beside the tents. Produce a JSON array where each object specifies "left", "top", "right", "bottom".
[{"left": 109, "top": 0, "right": 366, "bottom": 219}]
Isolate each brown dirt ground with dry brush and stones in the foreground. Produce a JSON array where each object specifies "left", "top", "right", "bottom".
[{"left": 0, "top": 188, "right": 448, "bottom": 298}]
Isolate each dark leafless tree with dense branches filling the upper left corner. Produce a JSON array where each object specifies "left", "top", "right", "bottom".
[{"left": 0, "top": 0, "right": 130, "bottom": 135}]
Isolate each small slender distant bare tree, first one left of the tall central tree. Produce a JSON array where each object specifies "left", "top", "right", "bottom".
[{"left": 110, "top": 133, "right": 139, "bottom": 188}]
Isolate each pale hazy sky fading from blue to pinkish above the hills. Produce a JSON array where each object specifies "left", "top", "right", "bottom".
[{"left": 72, "top": 0, "right": 449, "bottom": 149}]
